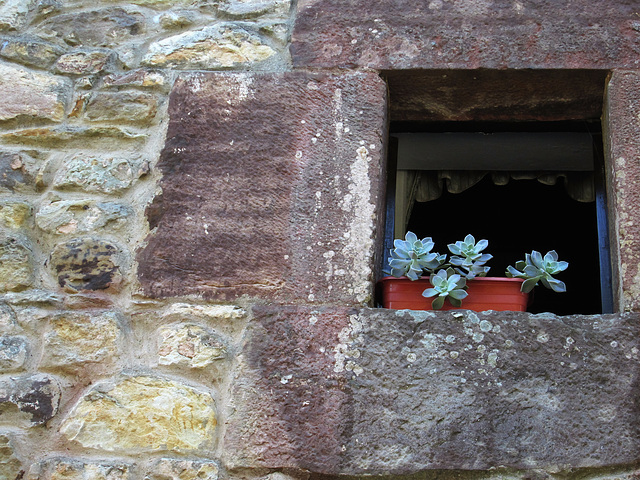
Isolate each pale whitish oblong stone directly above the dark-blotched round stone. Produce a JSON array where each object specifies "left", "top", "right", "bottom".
[{"left": 35, "top": 197, "right": 132, "bottom": 235}]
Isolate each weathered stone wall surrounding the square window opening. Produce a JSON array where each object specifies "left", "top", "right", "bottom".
[{"left": 0, "top": 0, "right": 640, "bottom": 480}]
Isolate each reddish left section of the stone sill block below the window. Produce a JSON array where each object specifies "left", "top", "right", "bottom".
[{"left": 224, "top": 306, "right": 357, "bottom": 473}]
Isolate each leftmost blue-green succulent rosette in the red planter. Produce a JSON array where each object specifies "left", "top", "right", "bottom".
[{"left": 389, "top": 232, "right": 447, "bottom": 280}]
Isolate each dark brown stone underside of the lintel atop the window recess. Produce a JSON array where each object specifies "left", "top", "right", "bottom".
[{"left": 385, "top": 70, "right": 608, "bottom": 122}]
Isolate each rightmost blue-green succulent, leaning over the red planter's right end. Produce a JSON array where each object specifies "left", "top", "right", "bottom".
[{"left": 505, "top": 250, "right": 569, "bottom": 293}]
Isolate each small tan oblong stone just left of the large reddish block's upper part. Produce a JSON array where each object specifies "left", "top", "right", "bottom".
[{"left": 85, "top": 92, "right": 158, "bottom": 124}]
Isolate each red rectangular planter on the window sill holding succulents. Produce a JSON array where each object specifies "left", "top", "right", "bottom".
[{"left": 378, "top": 277, "right": 529, "bottom": 312}]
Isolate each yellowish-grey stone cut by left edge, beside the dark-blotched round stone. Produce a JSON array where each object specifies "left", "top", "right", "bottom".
[{"left": 0, "top": 232, "right": 34, "bottom": 292}]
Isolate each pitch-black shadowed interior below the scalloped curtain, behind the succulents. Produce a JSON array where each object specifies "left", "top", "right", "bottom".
[{"left": 387, "top": 122, "right": 611, "bottom": 315}]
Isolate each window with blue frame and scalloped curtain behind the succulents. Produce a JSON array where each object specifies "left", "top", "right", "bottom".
[{"left": 384, "top": 122, "right": 613, "bottom": 315}]
